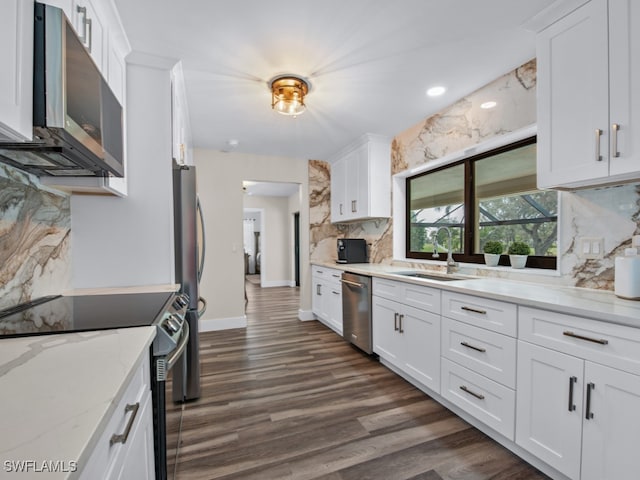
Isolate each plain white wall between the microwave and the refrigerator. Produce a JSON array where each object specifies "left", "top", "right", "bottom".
[{"left": 71, "top": 58, "right": 174, "bottom": 288}]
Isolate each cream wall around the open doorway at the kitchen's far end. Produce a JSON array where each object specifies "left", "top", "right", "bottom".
[{"left": 194, "top": 149, "right": 311, "bottom": 330}]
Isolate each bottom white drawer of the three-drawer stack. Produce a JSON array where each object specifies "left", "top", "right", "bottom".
[{"left": 441, "top": 358, "right": 516, "bottom": 440}]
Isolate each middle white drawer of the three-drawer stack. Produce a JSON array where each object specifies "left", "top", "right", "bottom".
[{"left": 442, "top": 318, "right": 516, "bottom": 388}]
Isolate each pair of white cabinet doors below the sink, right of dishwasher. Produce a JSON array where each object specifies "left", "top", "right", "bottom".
[{"left": 372, "top": 294, "right": 440, "bottom": 392}]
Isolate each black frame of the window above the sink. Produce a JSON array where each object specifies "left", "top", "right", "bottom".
[{"left": 404, "top": 134, "right": 558, "bottom": 270}]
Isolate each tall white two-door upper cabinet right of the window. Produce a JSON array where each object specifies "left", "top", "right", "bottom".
[{"left": 537, "top": 0, "right": 640, "bottom": 188}]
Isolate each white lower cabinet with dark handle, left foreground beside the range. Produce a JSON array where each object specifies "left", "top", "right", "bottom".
[{"left": 80, "top": 355, "right": 155, "bottom": 480}]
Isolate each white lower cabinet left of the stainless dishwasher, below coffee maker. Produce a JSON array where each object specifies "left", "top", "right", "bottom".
[{"left": 311, "top": 265, "right": 342, "bottom": 335}]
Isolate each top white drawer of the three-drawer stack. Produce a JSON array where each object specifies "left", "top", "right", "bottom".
[{"left": 442, "top": 292, "right": 518, "bottom": 337}]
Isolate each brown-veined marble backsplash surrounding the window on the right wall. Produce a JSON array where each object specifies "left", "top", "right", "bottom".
[{"left": 309, "top": 56, "right": 640, "bottom": 290}]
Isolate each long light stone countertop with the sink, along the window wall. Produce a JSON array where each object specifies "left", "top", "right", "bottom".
[{"left": 312, "top": 262, "right": 640, "bottom": 328}]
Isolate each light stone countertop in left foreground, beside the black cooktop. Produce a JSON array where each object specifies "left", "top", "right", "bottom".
[{"left": 0, "top": 326, "right": 156, "bottom": 480}]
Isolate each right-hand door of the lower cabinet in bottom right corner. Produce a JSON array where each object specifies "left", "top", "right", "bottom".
[{"left": 582, "top": 362, "right": 640, "bottom": 480}]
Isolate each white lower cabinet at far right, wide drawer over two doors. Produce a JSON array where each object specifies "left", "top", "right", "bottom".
[{"left": 516, "top": 307, "right": 640, "bottom": 480}]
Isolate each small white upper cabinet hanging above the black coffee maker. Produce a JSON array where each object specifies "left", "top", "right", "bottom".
[{"left": 331, "top": 134, "right": 391, "bottom": 223}]
